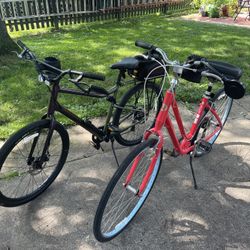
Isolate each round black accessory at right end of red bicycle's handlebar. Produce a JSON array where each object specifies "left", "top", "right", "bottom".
[{"left": 224, "top": 80, "right": 246, "bottom": 99}]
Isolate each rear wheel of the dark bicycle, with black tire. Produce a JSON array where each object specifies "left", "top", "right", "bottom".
[{"left": 113, "top": 82, "right": 162, "bottom": 146}]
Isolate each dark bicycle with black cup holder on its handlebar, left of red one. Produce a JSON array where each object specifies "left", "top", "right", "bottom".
[{"left": 0, "top": 41, "right": 164, "bottom": 207}]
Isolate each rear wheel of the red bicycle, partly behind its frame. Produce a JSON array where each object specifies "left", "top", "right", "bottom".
[{"left": 195, "top": 89, "right": 233, "bottom": 157}]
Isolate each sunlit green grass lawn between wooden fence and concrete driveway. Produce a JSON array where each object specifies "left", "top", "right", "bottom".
[{"left": 0, "top": 15, "right": 250, "bottom": 138}]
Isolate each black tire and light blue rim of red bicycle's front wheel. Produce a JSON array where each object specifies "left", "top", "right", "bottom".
[{"left": 93, "top": 138, "right": 162, "bottom": 242}]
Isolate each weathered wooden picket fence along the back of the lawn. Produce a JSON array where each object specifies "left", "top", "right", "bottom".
[{"left": 0, "top": 0, "right": 190, "bottom": 31}]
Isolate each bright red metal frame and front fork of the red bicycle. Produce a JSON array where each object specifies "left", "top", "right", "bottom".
[{"left": 124, "top": 82, "right": 223, "bottom": 196}]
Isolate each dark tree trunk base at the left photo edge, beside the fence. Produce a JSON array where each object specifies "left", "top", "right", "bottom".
[{"left": 0, "top": 17, "right": 17, "bottom": 55}]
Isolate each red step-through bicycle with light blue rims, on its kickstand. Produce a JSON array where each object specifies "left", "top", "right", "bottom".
[{"left": 94, "top": 41, "right": 245, "bottom": 242}]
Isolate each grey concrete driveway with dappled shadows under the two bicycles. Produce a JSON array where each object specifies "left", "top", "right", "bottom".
[{"left": 0, "top": 96, "right": 250, "bottom": 250}]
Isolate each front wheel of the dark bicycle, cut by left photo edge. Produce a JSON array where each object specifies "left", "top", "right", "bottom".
[{"left": 0, "top": 120, "right": 69, "bottom": 207}]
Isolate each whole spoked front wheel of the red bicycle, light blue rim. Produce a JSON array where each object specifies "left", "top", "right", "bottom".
[{"left": 93, "top": 139, "right": 162, "bottom": 242}]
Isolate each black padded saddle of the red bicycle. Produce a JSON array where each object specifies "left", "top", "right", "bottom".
[{"left": 208, "top": 61, "right": 243, "bottom": 80}]
